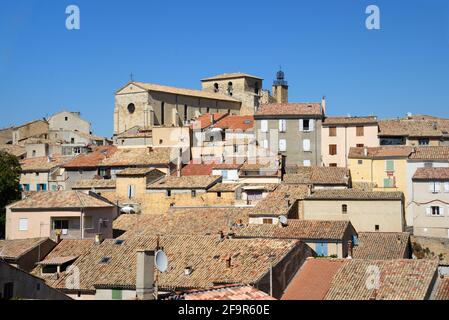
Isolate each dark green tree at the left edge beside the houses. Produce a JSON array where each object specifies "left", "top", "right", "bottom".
[{"left": 0, "top": 151, "right": 21, "bottom": 238}]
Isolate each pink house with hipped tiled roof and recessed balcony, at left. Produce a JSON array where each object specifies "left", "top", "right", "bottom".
[{"left": 6, "top": 191, "right": 117, "bottom": 240}]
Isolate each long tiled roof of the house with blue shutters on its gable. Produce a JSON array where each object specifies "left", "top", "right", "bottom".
[{"left": 235, "top": 219, "right": 351, "bottom": 241}]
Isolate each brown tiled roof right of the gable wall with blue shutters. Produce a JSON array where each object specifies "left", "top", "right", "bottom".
[{"left": 353, "top": 232, "right": 410, "bottom": 260}]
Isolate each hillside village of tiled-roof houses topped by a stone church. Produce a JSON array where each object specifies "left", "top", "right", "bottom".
[{"left": 0, "top": 71, "right": 449, "bottom": 300}]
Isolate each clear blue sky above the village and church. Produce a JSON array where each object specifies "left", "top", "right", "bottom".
[{"left": 0, "top": 0, "right": 449, "bottom": 136}]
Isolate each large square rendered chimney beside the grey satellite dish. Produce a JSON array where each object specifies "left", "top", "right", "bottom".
[{"left": 136, "top": 250, "right": 154, "bottom": 300}]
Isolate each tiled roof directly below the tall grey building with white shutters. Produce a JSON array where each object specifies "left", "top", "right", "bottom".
[{"left": 284, "top": 166, "right": 350, "bottom": 186}]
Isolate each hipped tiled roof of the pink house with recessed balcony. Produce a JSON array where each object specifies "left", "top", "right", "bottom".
[{"left": 11, "top": 191, "right": 113, "bottom": 211}]
